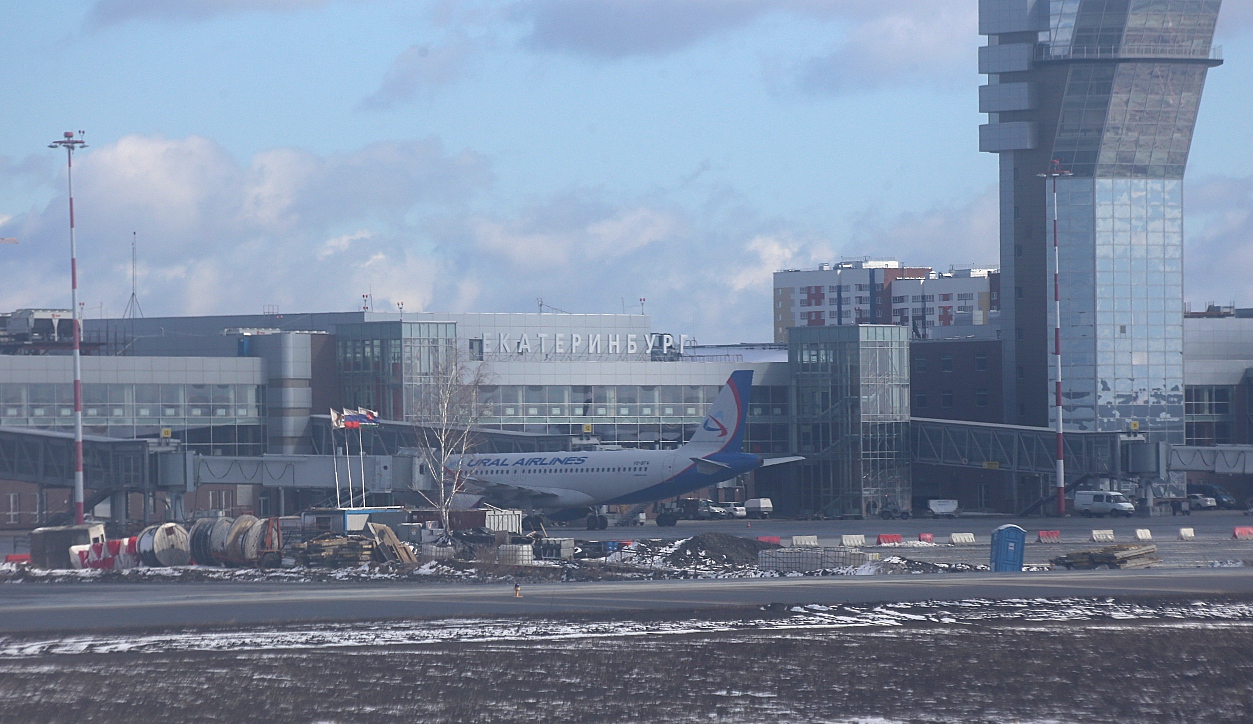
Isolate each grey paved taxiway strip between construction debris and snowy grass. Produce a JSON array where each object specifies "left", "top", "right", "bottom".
[{"left": 0, "top": 567, "right": 1253, "bottom": 634}]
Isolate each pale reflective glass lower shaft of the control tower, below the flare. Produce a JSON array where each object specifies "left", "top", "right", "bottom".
[{"left": 1049, "top": 178, "right": 1184, "bottom": 435}]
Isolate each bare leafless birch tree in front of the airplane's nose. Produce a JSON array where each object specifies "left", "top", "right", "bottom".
[{"left": 411, "top": 339, "right": 489, "bottom": 531}]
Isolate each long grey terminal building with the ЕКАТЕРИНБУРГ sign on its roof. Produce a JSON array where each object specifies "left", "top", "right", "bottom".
[{"left": 0, "top": 306, "right": 911, "bottom": 519}]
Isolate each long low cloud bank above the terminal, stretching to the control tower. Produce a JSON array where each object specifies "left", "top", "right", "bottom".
[{"left": 0, "top": 130, "right": 996, "bottom": 342}]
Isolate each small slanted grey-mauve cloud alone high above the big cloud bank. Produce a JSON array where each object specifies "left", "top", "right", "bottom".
[{"left": 361, "top": 35, "right": 487, "bottom": 110}]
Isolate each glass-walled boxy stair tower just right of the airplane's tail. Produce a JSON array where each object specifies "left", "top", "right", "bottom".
[{"left": 788, "top": 324, "right": 911, "bottom": 516}]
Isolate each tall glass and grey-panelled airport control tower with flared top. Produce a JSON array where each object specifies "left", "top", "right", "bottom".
[{"left": 979, "top": 0, "right": 1222, "bottom": 443}]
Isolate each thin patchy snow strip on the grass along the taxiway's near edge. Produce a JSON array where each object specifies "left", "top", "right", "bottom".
[{"left": 0, "top": 599, "right": 1253, "bottom": 660}]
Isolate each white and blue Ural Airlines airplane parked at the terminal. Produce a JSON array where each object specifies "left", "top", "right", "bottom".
[{"left": 445, "top": 370, "right": 804, "bottom": 530}]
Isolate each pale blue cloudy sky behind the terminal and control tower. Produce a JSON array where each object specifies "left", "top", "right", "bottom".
[{"left": 0, "top": 0, "right": 1253, "bottom": 342}]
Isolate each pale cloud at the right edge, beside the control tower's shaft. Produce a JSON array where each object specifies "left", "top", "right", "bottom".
[{"left": 1184, "top": 177, "right": 1253, "bottom": 309}]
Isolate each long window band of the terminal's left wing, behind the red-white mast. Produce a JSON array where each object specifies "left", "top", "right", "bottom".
[{"left": 0, "top": 382, "right": 266, "bottom": 455}]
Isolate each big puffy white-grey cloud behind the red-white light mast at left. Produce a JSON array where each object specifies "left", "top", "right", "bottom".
[{"left": 0, "top": 135, "right": 491, "bottom": 314}]
